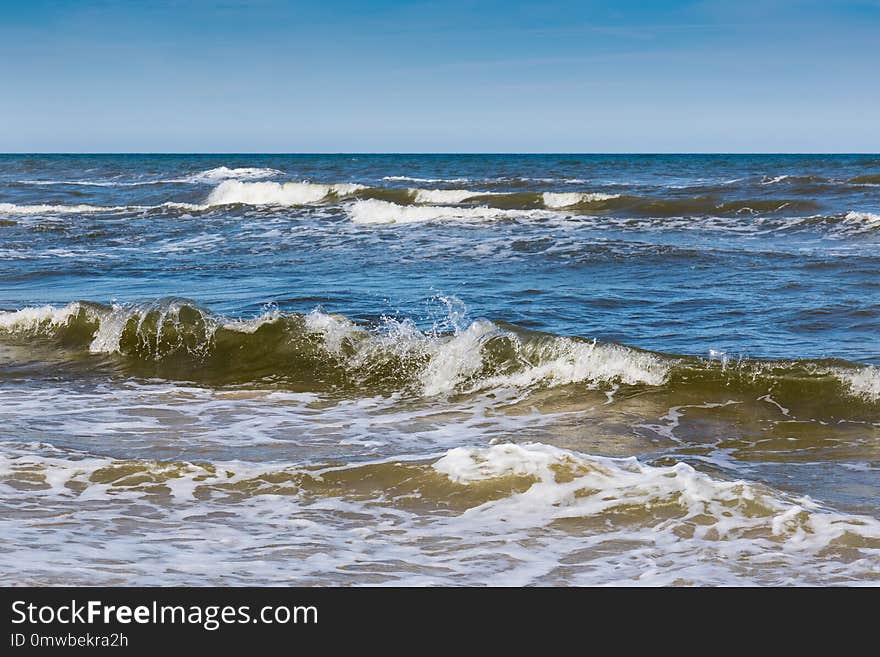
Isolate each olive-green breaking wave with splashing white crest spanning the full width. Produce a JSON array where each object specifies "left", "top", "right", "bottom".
[{"left": 0, "top": 299, "right": 880, "bottom": 408}]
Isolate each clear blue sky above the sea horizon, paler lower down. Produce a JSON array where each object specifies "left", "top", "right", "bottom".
[{"left": 0, "top": 0, "right": 880, "bottom": 153}]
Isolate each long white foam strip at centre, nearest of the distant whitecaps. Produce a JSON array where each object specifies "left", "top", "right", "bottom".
[{"left": 346, "top": 199, "right": 541, "bottom": 224}]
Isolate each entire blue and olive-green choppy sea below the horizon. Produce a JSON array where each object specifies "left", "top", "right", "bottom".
[{"left": 0, "top": 155, "right": 880, "bottom": 585}]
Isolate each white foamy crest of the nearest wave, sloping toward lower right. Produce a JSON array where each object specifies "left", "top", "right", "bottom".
[{"left": 433, "top": 443, "right": 880, "bottom": 558}]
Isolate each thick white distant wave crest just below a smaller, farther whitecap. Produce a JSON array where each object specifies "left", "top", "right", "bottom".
[{"left": 206, "top": 180, "right": 365, "bottom": 206}]
